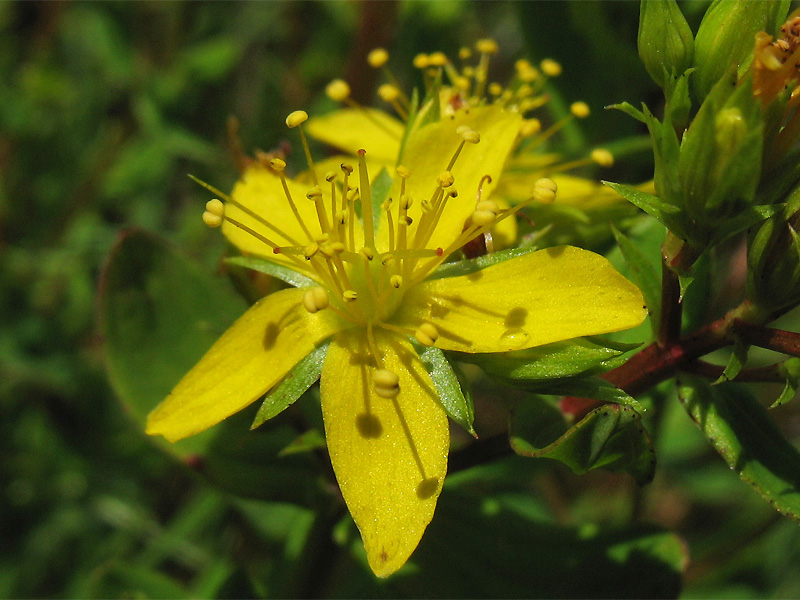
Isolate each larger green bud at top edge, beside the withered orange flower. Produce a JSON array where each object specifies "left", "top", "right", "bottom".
[{"left": 693, "top": 0, "right": 789, "bottom": 101}]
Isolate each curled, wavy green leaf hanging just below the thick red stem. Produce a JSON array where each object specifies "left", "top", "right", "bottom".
[{"left": 509, "top": 396, "right": 656, "bottom": 485}]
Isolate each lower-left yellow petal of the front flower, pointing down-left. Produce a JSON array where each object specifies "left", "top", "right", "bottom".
[{"left": 147, "top": 289, "right": 341, "bottom": 442}]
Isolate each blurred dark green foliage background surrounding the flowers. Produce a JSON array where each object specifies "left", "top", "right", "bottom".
[{"left": 0, "top": 0, "right": 800, "bottom": 597}]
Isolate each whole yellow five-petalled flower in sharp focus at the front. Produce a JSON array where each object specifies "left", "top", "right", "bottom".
[{"left": 147, "top": 106, "right": 645, "bottom": 577}]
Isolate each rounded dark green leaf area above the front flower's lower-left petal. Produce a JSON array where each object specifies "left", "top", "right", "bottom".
[{"left": 99, "top": 230, "right": 247, "bottom": 453}]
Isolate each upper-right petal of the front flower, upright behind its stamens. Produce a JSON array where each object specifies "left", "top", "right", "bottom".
[{"left": 378, "top": 106, "right": 521, "bottom": 248}]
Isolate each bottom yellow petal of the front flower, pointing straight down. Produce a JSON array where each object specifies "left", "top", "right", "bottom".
[{"left": 321, "top": 329, "right": 449, "bottom": 577}]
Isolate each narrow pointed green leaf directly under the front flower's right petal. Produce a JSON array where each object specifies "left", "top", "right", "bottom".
[{"left": 458, "top": 337, "right": 639, "bottom": 385}]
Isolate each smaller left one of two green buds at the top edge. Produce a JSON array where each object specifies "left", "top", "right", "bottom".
[{"left": 639, "top": 0, "right": 694, "bottom": 88}]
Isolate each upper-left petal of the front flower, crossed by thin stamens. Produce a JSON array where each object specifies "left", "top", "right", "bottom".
[{"left": 222, "top": 165, "right": 364, "bottom": 277}]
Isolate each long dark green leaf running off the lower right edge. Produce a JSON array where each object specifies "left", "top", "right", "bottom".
[{"left": 678, "top": 376, "right": 800, "bottom": 520}]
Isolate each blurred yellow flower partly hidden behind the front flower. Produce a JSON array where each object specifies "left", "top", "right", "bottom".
[{"left": 308, "top": 39, "right": 623, "bottom": 248}]
